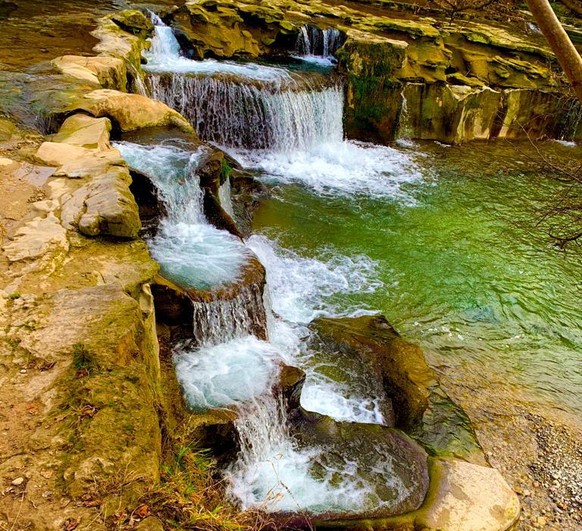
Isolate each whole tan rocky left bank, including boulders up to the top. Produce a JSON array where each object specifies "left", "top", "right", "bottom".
[{"left": 0, "top": 11, "right": 201, "bottom": 530}]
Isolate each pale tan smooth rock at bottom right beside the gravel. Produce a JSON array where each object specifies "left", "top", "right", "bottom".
[{"left": 416, "top": 459, "right": 520, "bottom": 531}]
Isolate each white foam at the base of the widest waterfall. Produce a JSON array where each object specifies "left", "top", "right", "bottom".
[{"left": 231, "top": 141, "right": 422, "bottom": 198}]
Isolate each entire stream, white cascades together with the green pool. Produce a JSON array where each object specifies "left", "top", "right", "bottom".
[{"left": 116, "top": 16, "right": 582, "bottom": 514}]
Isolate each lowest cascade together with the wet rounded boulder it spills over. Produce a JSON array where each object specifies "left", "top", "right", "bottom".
[{"left": 226, "top": 393, "right": 427, "bottom": 517}]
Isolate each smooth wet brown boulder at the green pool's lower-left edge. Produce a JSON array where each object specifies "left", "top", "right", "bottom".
[{"left": 312, "top": 316, "right": 486, "bottom": 464}]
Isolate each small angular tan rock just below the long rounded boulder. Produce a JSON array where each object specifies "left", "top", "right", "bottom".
[{"left": 52, "top": 114, "right": 111, "bottom": 151}]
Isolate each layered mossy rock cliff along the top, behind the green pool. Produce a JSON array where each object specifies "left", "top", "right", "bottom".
[{"left": 165, "top": 0, "right": 582, "bottom": 143}]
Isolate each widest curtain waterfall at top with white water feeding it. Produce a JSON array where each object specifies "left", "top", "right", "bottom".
[{"left": 144, "top": 17, "right": 343, "bottom": 152}]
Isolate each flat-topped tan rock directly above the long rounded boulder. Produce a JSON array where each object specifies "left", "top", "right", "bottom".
[{"left": 52, "top": 55, "right": 127, "bottom": 91}]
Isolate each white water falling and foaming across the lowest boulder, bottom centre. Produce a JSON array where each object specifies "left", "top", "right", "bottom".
[{"left": 226, "top": 395, "right": 408, "bottom": 514}]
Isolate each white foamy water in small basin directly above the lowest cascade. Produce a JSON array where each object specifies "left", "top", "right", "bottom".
[{"left": 174, "top": 336, "right": 281, "bottom": 411}]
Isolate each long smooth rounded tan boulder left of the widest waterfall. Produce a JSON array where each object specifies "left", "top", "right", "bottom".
[{"left": 69, "top": 89, "right": 194, "bottom": 133}]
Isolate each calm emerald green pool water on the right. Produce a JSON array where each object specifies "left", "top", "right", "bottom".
[{"left": 255, "top": 143, "right": 582, "bottom": 420}]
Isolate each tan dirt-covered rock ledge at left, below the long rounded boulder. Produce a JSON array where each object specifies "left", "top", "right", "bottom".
[{"left": 0, "top": 110, "right": 162, "bottom": 530}]
